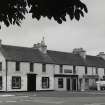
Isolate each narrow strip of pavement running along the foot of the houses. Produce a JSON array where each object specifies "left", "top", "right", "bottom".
[{"left": 0, "top": 91, "right": 105, "bottom": 97}]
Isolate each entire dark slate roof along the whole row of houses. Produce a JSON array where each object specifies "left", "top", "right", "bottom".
[{"left": 0, "top": 45, "right": 105, "bottom": 67}]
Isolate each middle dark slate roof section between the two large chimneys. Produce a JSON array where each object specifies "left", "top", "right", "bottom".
[{"left": 48, "top": 50, "right": 85, "bottom": 65}]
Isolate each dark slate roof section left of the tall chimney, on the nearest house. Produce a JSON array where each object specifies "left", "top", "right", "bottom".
[{"left": 2, "top": 45, "right": 54, "bottom": 63}]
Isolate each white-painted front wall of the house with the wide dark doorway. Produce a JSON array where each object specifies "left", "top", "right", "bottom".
[{"left": 7, "top": 62, "right": 54, "bottom": 91}]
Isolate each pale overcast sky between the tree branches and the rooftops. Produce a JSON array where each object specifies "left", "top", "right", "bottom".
[{"left": 0, "top": 0, "right": 105, "bottom": 55}]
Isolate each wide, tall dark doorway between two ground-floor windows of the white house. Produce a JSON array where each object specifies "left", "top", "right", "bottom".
[{"left": 27, "top": 74, "right": 36, "bottom": 91}]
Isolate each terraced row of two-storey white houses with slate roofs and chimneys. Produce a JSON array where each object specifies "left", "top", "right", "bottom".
[{"left": 0, "top": 39, "right": 105, "bottom": 92}]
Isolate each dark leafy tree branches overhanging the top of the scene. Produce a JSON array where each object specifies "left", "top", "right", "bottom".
[{"left": 0, "top": 0, "right": 88, "bottom": 27}]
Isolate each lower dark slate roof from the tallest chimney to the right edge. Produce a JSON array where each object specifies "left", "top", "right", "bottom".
[{"left": 48, "top": 50, "right": 105, "bottom": 68}]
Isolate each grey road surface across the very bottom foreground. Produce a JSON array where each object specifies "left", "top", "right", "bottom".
[{"left": 0, "top": 92, "right": 105, "bottom": 105}]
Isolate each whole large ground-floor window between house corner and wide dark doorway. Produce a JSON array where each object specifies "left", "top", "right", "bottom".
[{"left": 12, "top": 77, "right": 21, "bottom": 89}]
